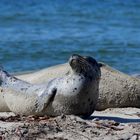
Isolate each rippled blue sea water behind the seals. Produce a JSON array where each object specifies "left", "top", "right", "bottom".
[{"left": 0, "top": 0, "right": 140, "bottom": 74}]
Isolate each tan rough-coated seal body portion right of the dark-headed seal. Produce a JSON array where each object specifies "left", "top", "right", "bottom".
[{"left": 96, "top": 63, "right": 140, "bottom": 110}]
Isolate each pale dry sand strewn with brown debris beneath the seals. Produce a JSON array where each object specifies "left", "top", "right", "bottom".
[{"left": 0, "top": 108, "right": 140, "bottom": 140}]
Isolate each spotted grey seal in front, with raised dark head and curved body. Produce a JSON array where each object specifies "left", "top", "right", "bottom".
[{"left": 0, "top": 54, "right": 101, "bottom": 117}]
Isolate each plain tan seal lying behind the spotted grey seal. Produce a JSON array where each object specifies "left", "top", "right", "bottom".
[{"left": 18, "top": 62, "right": 140, "bottom": 110}]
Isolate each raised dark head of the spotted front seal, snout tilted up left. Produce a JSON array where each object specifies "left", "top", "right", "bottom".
[{"left": 69, "top": 54, "right": 100, "bottom": 75}]
